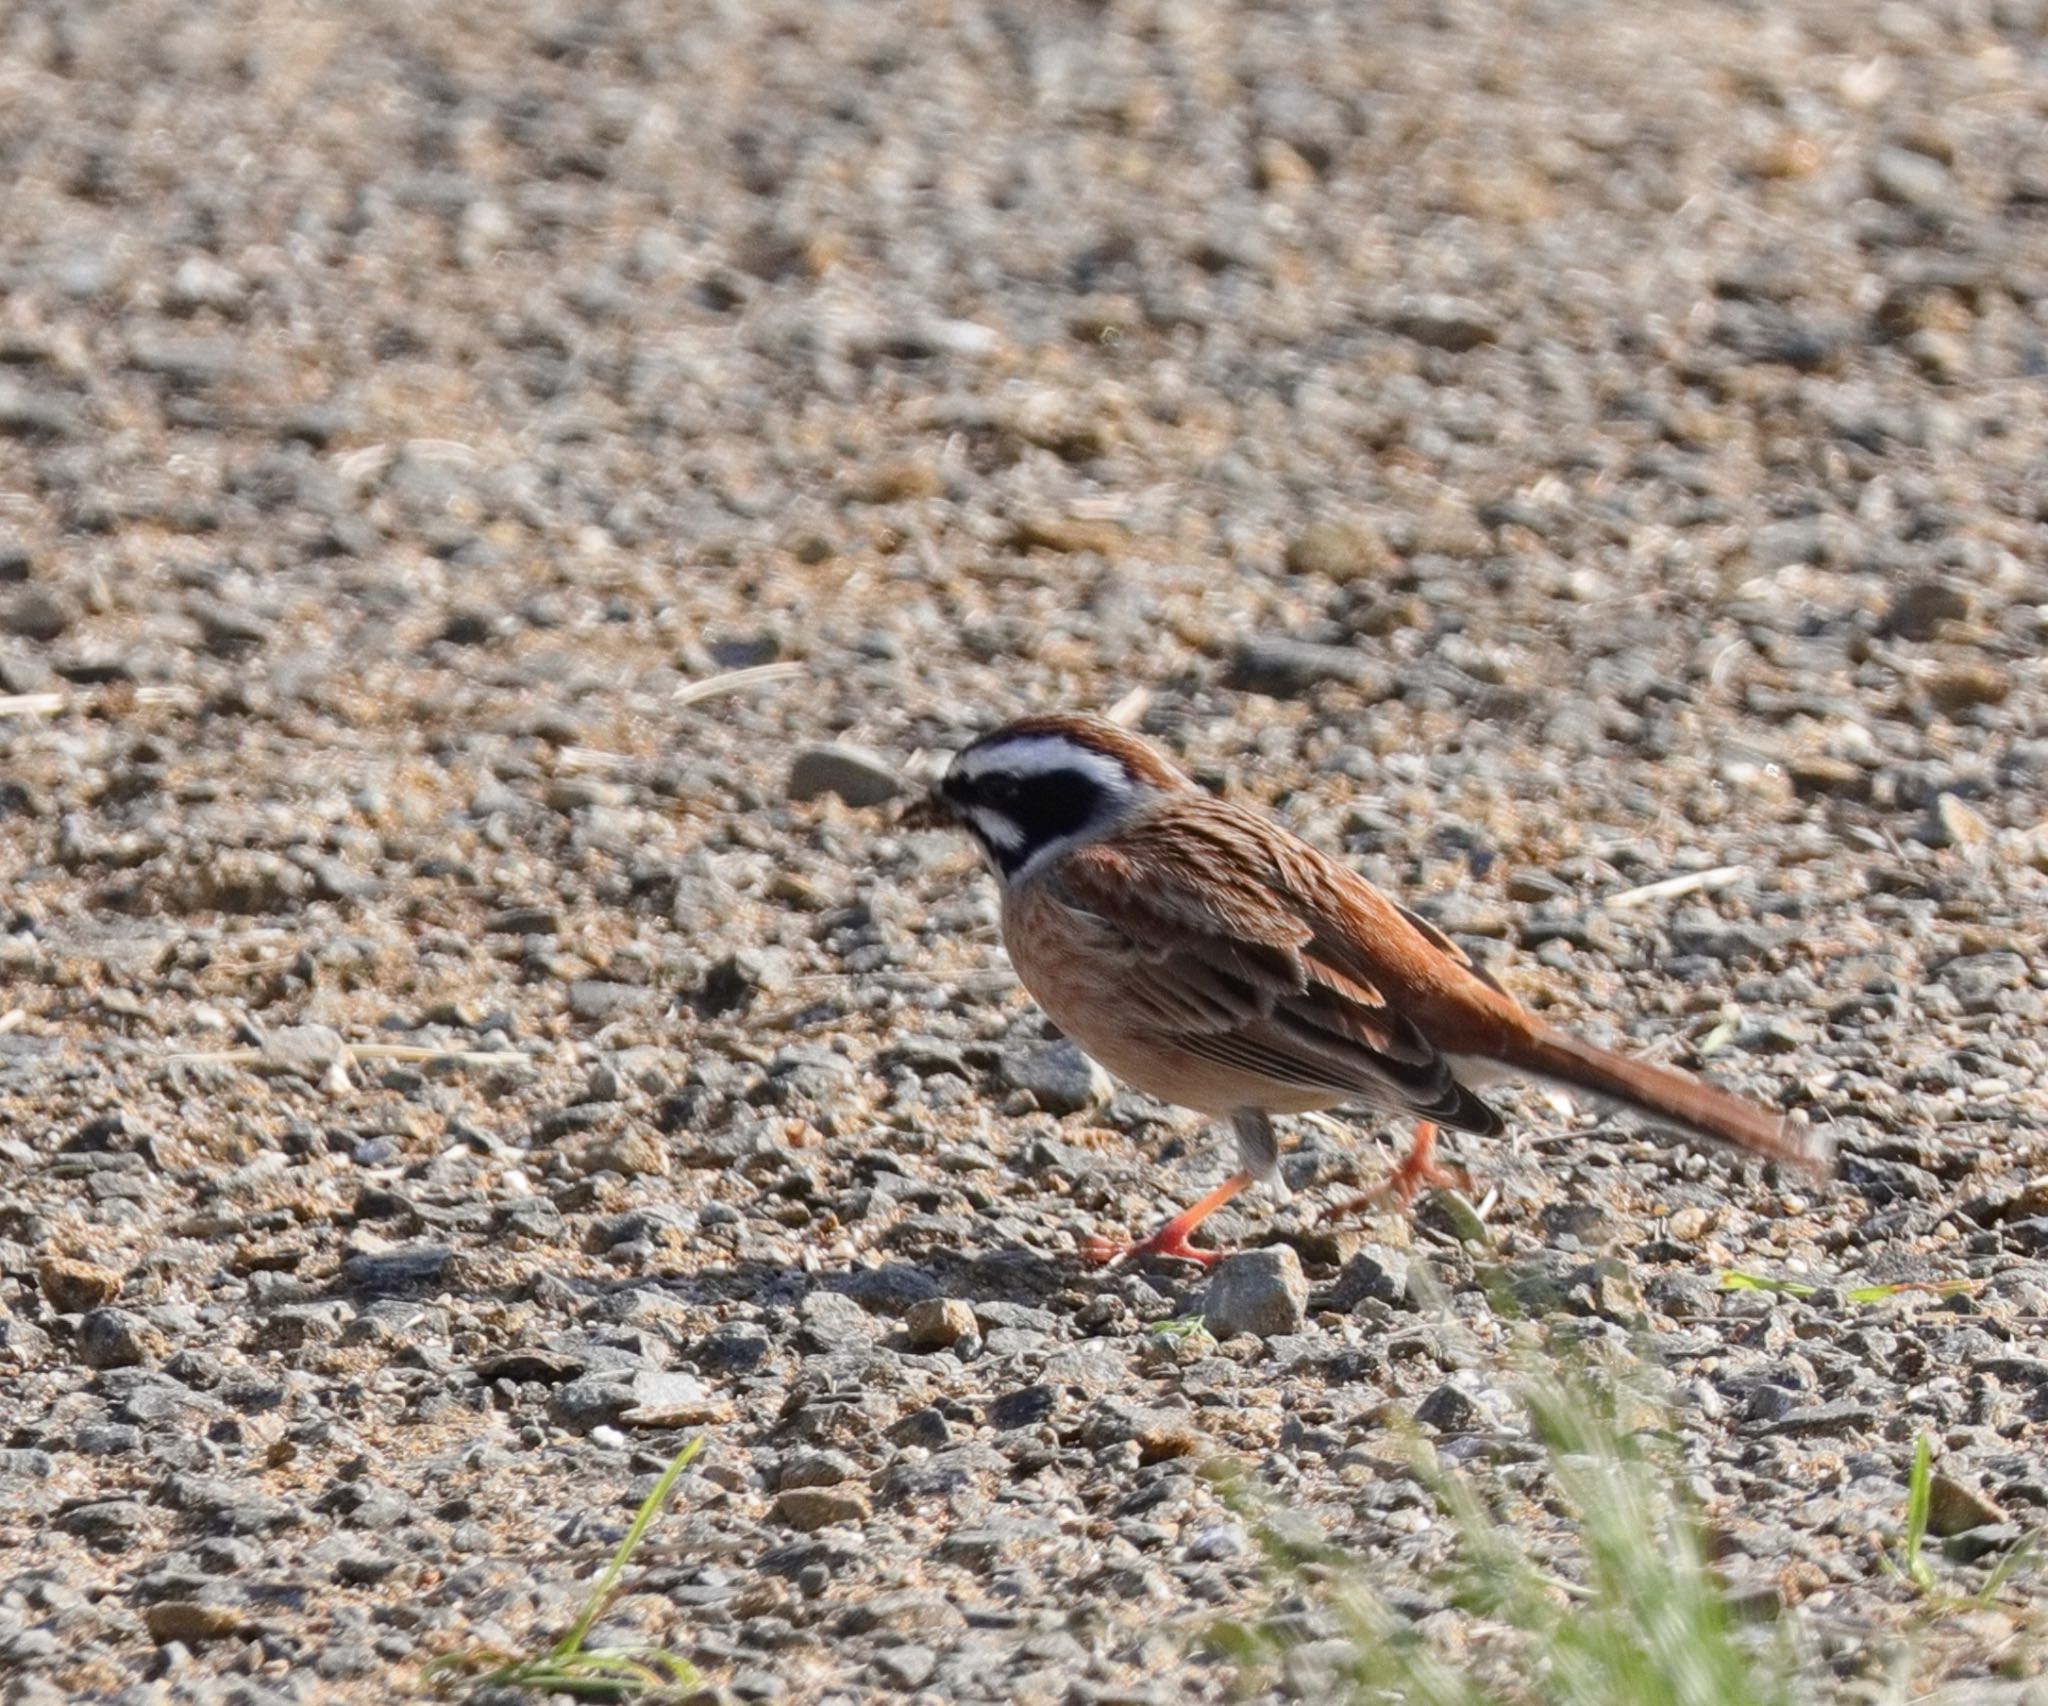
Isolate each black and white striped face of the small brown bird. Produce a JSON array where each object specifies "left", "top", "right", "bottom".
[{"left": 938, "top": 733, "right": 1139, "bottom": 883}]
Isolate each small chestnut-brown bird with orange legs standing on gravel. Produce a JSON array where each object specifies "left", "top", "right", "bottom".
[{"left": 901, "top": 711, "right": 1833, "bottom": 1266}]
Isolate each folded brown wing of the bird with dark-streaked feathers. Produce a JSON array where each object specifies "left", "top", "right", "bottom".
[{"left": 1053, "top": 811, "right": 1499, "bottom": 1135}]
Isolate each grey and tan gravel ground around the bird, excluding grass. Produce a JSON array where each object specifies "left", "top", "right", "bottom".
[{"left": 0, "top": 0, "right": 2048, "bottom": 1706}]
